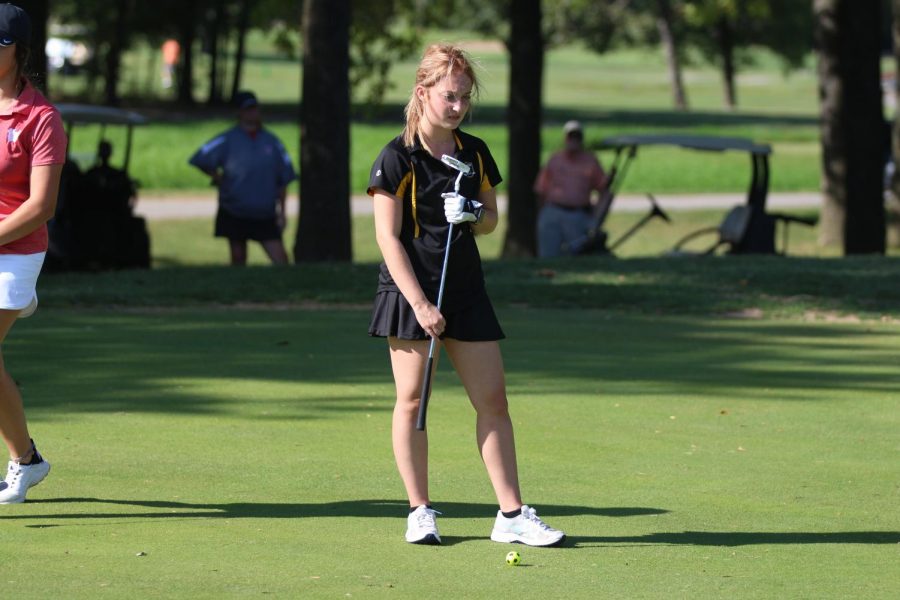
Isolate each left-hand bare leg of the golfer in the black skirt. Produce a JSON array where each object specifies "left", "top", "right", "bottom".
[{"left": 388, "top": 337, "right": 437, "bottom": 506}]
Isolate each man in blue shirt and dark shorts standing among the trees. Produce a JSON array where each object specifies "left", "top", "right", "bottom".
[{"left": 189, "top": 91, "right": 297, "bottom": 265}]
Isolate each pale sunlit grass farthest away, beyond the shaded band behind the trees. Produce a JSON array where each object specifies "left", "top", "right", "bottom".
[{"left": 50, "top": 29, "right": 817, "bottom": 116}]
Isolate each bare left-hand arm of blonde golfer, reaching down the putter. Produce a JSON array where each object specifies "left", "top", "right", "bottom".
[{"left": 374, "top": 190, "right": 428, "bottom": 308}]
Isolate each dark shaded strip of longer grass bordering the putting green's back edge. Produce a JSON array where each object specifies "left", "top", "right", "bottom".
[{"left": 39, "top": 250, "right": 900, "bottom": 320}]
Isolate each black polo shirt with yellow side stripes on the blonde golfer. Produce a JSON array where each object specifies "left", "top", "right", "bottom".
[{"left": 368, "top": 129, "right": 502, "bottom": 313}]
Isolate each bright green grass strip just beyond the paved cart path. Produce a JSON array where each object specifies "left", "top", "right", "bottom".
[{"left": 72, "top": 117, "right": 820, "bottom": 199}]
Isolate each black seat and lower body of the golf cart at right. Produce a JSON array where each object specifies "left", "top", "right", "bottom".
[{"left": 666, "top": 204, "right": 818, "bottom": 256}]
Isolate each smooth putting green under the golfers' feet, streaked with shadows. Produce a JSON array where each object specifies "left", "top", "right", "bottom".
[{"left": 0, "top": 302, "right": 900, "bottom": 598}]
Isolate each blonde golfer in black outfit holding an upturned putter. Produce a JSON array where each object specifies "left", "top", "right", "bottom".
[{"left": 368, "top": 45, "right": 565, "bottom": 546}]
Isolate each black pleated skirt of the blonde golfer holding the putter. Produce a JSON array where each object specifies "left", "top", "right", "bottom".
[{"left": 369, "top": 292, "right": 506, "bottom": 342}]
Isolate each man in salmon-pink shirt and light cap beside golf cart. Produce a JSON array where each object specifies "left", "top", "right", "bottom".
[{"left": 534, "top": 121, "right": 607, "bottom": 258}]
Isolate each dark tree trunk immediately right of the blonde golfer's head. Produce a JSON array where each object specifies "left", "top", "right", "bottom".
[{"left": 503, "top": 0, "right": 544, "bottom": 257}]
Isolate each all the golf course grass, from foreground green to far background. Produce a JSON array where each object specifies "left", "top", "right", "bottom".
[{"left": 26, "top": 23, "right": 900, "bottom": 598}]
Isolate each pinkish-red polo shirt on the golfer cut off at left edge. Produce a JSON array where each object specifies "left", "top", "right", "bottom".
[{"left": 0, "top": 83, "right": 67, "bottom": 254}]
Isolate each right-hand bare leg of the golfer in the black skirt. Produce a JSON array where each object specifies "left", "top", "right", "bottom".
[{"left": 444, "top": 339, "right": 522, "bottom": 511}]
